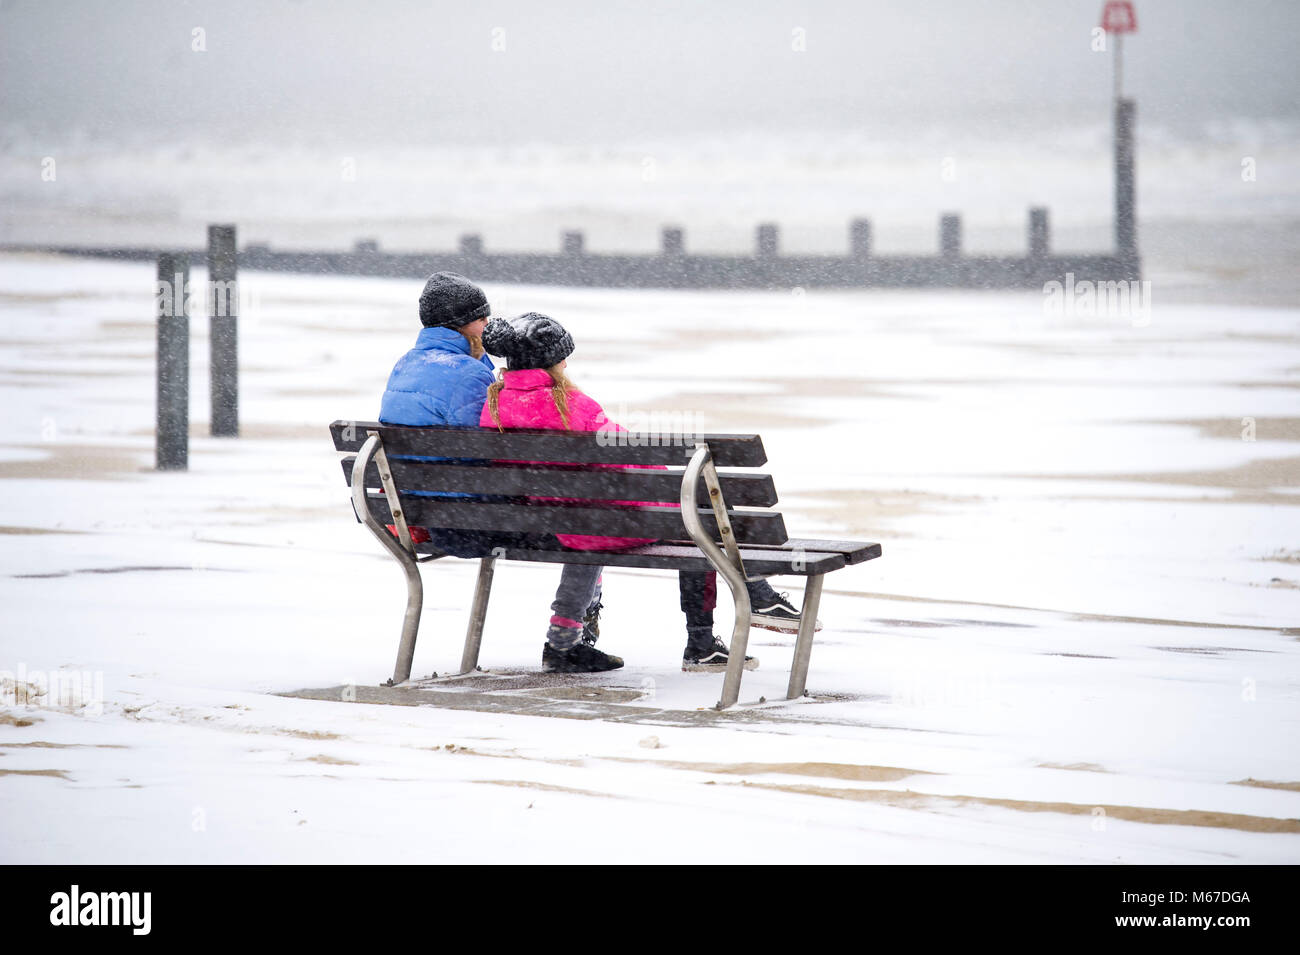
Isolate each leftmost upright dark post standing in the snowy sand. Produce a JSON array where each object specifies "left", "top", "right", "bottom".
[{"left": 155, "top": 252, "right": 190, "bottom": 470}]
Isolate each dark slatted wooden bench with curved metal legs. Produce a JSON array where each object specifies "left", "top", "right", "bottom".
[{"left": 330, "top": 421, "right": 880, "bottom": 708}]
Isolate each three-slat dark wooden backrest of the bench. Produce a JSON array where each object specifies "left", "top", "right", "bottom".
[{"left": 330, "top": 421, "right": 788, "bottom": 544}]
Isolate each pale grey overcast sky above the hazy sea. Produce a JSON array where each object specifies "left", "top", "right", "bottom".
[{"left": 0, "top": 0, "right": 1300, "bottom": 143}]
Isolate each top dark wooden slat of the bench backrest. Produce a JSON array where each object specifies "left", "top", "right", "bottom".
[{"left": 329, "top": 421, "right": 767, "bottom": 468}]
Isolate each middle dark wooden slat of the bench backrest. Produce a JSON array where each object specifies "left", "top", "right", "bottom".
[{"left": 343, "top": 455, "right": 776, "bottom": 507}]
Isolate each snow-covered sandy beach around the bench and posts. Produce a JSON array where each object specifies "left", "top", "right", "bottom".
[{"left": 0, "top": 256, "right": 1300, "bottom": 863}]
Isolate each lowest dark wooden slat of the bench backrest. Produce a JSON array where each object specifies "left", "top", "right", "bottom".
[{"left": 368, "top": 494, "right": 789, "bottom": 544}]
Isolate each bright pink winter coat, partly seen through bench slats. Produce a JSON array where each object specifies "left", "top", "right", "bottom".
[{"left": 478, "top": 368, "right": 655, "bottom": 551}]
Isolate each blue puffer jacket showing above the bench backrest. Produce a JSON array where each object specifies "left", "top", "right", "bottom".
[{"left": 380, "top": 327, "right": 493, "bottom": 427}]
